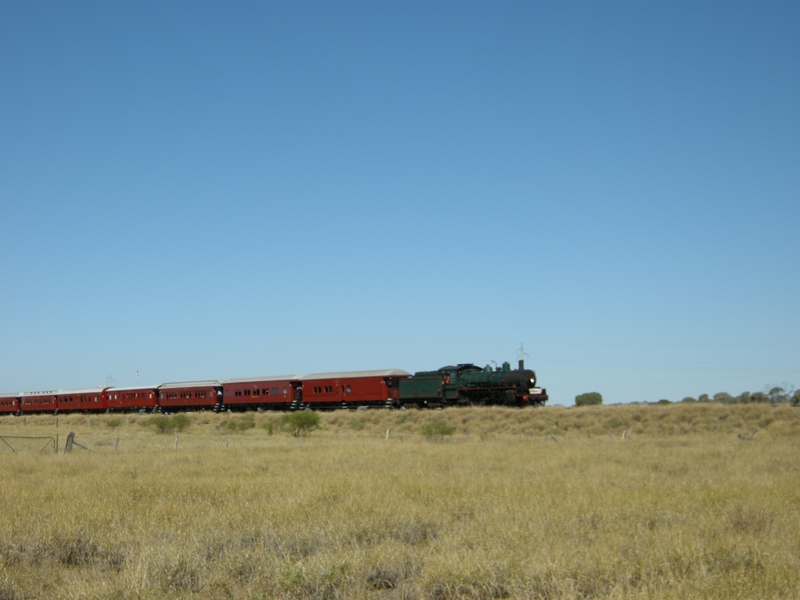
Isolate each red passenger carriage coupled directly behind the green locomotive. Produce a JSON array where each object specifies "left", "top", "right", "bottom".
[{"left": 302, "top": 369, "right": 411, "bottom": 408}]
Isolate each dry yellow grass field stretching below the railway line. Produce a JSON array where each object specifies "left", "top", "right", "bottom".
[{"left": 0, "top": 403, "right": 800, "bottom": 600}]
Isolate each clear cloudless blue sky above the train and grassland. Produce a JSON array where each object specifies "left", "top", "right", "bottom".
[{"left": 0, "top": 0, "right": 800, "bottom": 405}]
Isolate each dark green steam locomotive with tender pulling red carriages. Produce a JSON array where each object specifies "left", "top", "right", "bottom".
[{"left": 397, "top": 360, "right": 547, "bottom": 407}]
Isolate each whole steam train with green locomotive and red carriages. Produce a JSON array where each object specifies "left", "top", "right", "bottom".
[{"left": 0, "top": 360, "right": 548, "bottom": 415}]
